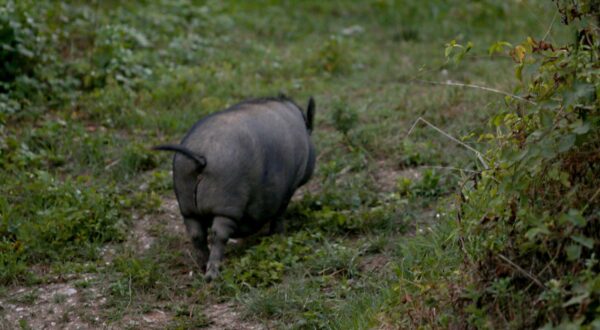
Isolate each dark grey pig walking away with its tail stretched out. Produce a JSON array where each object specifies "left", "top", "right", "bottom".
[{"left": 154, "top": 95, "right": 315, "bottom": 281}]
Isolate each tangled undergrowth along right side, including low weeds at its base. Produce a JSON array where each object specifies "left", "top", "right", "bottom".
[{"left": 384, "top": 1, "right": 600, "bottom": 329}]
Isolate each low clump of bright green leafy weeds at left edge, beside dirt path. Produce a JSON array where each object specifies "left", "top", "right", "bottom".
[{"left": 0, "top": 171, "right": 127, "bottom": 283}]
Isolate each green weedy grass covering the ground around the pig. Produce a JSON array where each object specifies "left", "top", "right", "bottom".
[{"left": 0, "top": 0, "right": 576, "bottom": 329}]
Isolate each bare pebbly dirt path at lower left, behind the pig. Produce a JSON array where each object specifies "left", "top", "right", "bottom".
[{"left": 0, "top": 198, "right": 266, "bottom": 330}]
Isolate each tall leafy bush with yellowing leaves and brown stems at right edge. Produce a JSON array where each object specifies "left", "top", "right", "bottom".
[{"left": 460, "top": 1, "right": 600, "bottom": 326}]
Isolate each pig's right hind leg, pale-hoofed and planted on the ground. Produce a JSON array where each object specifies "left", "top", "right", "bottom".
[{"left": 204, "top": 216, "right": 236, "bottom": 281}]
